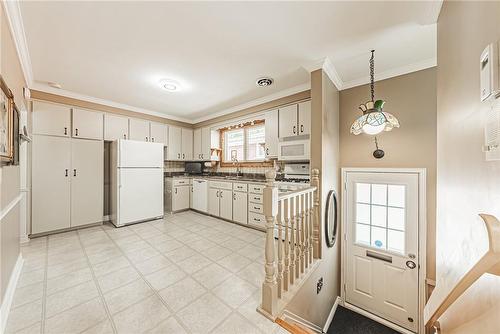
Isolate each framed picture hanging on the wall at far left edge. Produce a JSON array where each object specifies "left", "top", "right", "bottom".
[{"left": 0, "top": 76, "right": 15, "bottom": 163}]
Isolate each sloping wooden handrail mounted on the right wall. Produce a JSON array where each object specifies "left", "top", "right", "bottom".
[{"left": 424, "top": 214, "right": 500, "bottom": 328}]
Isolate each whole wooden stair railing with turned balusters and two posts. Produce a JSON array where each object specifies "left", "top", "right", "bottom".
[{"left": 257, "top": 169, "right": 320, "bottom": 321}]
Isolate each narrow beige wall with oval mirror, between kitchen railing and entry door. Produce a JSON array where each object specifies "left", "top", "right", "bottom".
[{"left": 287, "top": 70, "right": 340, "bottom": 328}]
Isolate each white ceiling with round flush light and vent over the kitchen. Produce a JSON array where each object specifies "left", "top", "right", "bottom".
[{"left": 15, "top": 1, "right": 440, "bottom": 121}]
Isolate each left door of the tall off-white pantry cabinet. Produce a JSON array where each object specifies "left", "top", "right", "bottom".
[{"left": 31, "top": 135, "right": 71, "bottom": 234}]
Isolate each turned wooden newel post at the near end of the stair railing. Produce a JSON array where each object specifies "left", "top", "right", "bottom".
[{"left": 262, "top": 170, "right": 278, "bottom": 316}]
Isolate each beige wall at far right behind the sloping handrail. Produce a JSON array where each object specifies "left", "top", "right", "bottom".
[{"left": 436, "top": 1, "right": 500, "bottom": 333}]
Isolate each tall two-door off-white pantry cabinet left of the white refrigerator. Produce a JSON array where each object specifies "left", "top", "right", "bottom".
[{"left": 31, "top": 135, "right": 104, "bottom": 234}]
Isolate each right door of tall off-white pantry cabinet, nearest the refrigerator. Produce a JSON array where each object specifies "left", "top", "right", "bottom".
[{"left": 70, "top": 140, "right": 104, "bottom": 227}]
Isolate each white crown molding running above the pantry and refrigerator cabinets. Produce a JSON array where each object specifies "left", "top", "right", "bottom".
[{"left": 31, "top": 82, "right": 193, "bottom": 124}]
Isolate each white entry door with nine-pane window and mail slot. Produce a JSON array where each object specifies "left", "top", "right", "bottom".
[{"left": 344, "top": 172, "right": 419, "bottom": 332}]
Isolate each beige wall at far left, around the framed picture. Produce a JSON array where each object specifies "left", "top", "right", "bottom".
[{"left": 0, "top": 3, "right": 25, "bottom": 302}]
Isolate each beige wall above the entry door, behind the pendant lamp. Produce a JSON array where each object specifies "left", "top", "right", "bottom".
[{"left": 340, "top": 68, "right": 437, "bottom": 279}]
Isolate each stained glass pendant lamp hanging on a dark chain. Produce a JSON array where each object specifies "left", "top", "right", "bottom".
[{"left": 351, "top": 50, "right": 399, "bottom": 135}]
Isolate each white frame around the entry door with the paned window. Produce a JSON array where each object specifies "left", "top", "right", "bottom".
[{"left": 340, "top": 167, "right": 427, "bottom": 334}]
